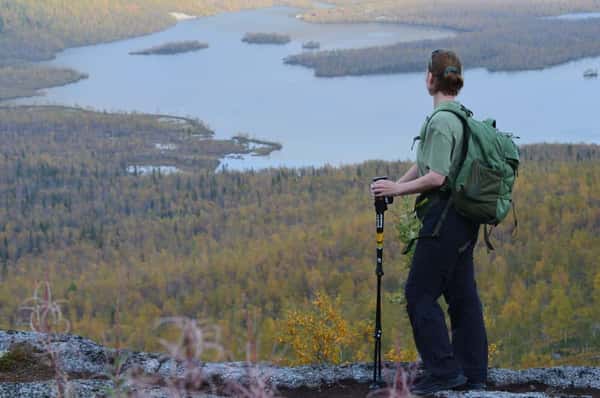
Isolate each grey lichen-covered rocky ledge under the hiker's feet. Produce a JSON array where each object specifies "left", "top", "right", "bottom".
[{"left": 0, "top": 331, "right": 600, "bottom": 398}]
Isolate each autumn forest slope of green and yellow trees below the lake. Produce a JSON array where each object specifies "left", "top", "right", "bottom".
[{"left": 0, "top": 105, "right": 600, "bottom": 367}]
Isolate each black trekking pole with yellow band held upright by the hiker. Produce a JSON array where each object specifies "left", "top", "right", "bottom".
[{"left": 370, "top": 177, "right": 394, "bottom": 389}]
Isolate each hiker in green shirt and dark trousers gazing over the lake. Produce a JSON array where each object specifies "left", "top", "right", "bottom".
[{"left": 371, "top": 50, "right": 488, "bottom": 395}]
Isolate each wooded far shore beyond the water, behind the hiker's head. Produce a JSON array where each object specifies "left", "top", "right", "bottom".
[{"left": 285, "top": 0, "right": 600, "bottom": 77}]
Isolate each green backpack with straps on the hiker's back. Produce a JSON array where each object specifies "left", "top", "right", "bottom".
[{"left": 405, "top": 101, "right": 519, "bottom": 252}]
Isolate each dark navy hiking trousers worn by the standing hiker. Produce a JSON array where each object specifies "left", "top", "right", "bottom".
[{"left": 405, "top": 200, "right": 488, "bottom": 382}]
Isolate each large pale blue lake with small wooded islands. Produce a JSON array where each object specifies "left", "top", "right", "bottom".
[{"left": 18, "top": 7, "right": 600, "bottom": 169}]
